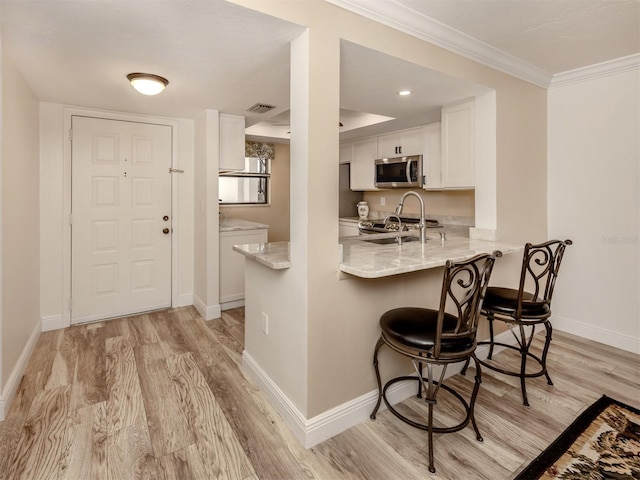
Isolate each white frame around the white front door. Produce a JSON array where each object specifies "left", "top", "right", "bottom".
[{"left": 61, "top": 107, "right": 180, "bottom": 328}]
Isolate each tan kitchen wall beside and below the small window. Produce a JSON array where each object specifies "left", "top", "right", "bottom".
[{"left": 220, "top": 143, "right": 290, "bottom": 242}]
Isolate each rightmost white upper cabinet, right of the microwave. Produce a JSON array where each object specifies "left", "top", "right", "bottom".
[{"left": 441, "top": 100, "right": 476, "bottom": 188}]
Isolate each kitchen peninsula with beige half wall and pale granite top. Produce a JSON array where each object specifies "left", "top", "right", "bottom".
[{"left": 234, "top": 225, "right": 521, "bottom": 447}]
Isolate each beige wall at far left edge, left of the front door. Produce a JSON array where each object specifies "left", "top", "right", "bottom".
[{"left": 2, "top": 52, "right": 40, "bottom": 390}]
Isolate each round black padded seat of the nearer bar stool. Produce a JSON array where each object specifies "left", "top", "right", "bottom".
[{"left": 380, "top": 307, "right": 475, "bottom": 353}]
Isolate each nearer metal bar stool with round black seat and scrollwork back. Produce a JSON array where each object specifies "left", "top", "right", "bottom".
[{"left": 371, "top": 251, "right": 502, "bottom": 473}]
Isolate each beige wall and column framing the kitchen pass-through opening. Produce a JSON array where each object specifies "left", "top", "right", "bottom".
[{"left": 234, "top": 0, "right": 547, "bottom": 418}]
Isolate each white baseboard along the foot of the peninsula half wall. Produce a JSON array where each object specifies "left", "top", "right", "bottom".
[{"left": 242, "top": 331, "right": 515, "bottom": 448}]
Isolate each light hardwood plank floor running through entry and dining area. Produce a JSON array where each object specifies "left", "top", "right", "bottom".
[{"left": 0, "top": 307, "right": 640, "bottom": 480}]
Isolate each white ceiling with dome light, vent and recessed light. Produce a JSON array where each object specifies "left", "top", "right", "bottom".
[{"left": 0, "top": 0, "right": 640, "bottom": 142}]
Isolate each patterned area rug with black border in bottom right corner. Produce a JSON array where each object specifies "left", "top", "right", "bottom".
[{"left": 515, "top": 395, "right": 640, "bottom": 480}]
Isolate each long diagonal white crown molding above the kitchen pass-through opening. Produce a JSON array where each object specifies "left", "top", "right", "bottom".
[{"left": 326, "top": 0, "right": 553, "bottom": 88}]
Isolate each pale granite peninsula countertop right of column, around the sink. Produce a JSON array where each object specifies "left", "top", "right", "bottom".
[{"left": 340, "top": 231, "right": 523, "bottom": 278}]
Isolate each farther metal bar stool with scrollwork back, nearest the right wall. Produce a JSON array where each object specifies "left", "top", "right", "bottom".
[{"left": 462, "top": 240, "right": 573, "bottom": 407}]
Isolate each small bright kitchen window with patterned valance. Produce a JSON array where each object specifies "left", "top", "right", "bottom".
[{"left": 218, "top": 142, "right": 273, "bottom": 205}]
